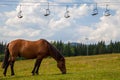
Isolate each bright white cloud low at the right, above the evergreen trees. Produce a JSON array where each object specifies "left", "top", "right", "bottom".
[{"left": 91, "top": 14, "right": 120, "bottom": 41}]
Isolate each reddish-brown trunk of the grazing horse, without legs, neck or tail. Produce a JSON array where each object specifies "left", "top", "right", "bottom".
[{"left": 9, "top": 39, "right": 48, "bottom": 59}]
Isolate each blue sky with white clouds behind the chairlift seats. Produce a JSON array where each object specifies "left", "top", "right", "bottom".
[{"left": 0, "top": 0, "right": 120, "bottom": 43}]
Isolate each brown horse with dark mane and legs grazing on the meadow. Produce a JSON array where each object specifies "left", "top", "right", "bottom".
[{"left": 2, "top": 39, "right": 66, "bottom": 76}]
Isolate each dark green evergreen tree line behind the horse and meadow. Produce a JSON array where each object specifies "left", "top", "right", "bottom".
[{"left": 0, "top": 40, "right": 120, "bottom": 56}]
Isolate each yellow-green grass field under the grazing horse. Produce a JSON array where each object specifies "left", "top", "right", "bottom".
[{"left": 0, "top": 54, "right": 120, "bottom": 80}]
